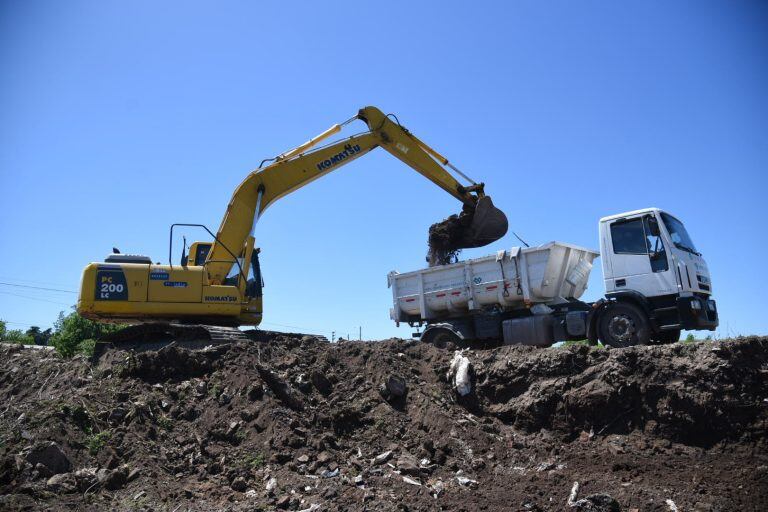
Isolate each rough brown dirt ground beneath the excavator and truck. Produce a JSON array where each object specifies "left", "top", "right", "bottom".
[{"left": 0, "top": 336, "right": 768, "bottom": 512}]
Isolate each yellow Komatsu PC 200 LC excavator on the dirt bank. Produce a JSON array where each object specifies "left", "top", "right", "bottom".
[{"left": 77, "top": 107, "right": 507, "bottom": 348}]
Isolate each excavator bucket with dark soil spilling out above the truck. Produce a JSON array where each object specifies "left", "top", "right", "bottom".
[{"left": 427, "top": 196, "right": 509, "bottom": 267}]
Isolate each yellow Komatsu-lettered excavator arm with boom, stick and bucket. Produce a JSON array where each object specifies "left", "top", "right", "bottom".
[{"left": 206, "top": 107, "right": 507, "bottom": 284}]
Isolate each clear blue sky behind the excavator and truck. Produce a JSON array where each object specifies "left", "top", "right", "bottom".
[{"left": 0, "top": 1, "right": 768, "bottom": 339}]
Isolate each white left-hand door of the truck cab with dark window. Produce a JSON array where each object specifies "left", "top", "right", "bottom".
[{"left": 606, "top": 214, "right": 677, "bottom": 297}]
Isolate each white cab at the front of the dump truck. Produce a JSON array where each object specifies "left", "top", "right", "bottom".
[{"left": 598, "top": 208, "right": 718, "bottom": 345}]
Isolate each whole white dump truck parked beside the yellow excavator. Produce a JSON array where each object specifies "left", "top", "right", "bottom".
[{"left": 388, "top": 208, "right": 718, "bottom": 347}]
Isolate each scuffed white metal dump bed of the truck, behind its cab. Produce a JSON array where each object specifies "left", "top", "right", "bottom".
[{"left": 388, "top": 242, "right": 599, "bottom": 322}]
